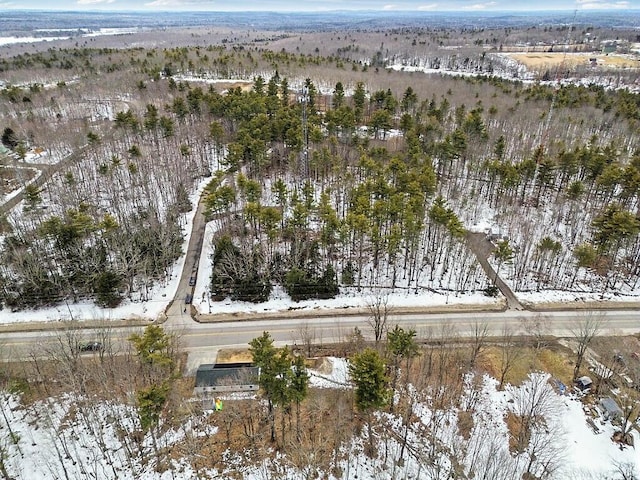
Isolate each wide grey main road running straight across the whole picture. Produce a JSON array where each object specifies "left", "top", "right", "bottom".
[{"left": 0, "top": 310, "right": 640, "bottom": 360}]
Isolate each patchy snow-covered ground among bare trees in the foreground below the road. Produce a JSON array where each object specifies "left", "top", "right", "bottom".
[{"left": 0, "top": 358, "right": 640, "bottom": 480}]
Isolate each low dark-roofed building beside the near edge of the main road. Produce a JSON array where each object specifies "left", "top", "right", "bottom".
[{"left": 193, "top": 363, "right": 259, "bottom": 396}]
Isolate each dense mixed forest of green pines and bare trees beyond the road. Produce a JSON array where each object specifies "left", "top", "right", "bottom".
[{"left": 0, "top": 24, "right": 640, "bottom": 309}]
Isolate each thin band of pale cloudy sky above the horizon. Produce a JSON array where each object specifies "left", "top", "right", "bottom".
[{"left": 0, "top": 0, "right": 640, "bottom": 12}]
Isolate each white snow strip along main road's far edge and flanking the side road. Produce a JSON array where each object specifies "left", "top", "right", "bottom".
[{"left": 5, "top": 180, "right": 640, "bottom": 324}]
